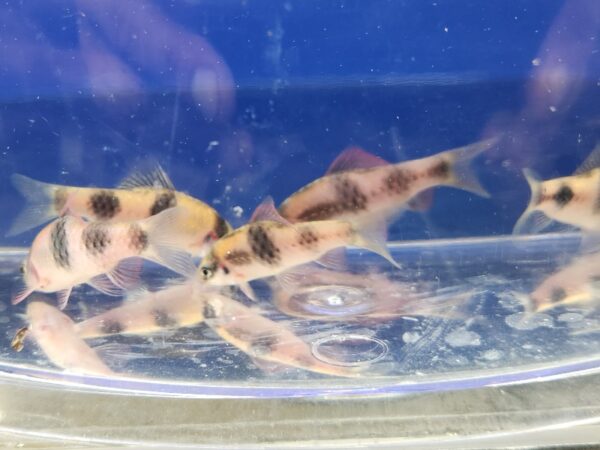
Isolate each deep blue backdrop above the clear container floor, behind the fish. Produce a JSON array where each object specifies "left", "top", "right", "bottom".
[{"left": 0, "top": 0, "right": 600, "bottom": 245}]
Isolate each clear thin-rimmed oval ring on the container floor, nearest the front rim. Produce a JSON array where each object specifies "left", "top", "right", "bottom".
[{"left": 312, "top": 334, "right": 389, "bottom": 367}]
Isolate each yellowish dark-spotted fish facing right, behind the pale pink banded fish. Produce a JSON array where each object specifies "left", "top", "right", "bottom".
[{"left": 7, "top": 165, "right": 231, "bottom": 256}]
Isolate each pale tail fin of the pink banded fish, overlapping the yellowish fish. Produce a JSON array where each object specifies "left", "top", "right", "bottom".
[{"left": 140, "top": 207, "right": 196, "bottom": 278}]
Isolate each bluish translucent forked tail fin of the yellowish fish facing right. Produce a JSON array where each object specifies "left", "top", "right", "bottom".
[{"left": 6, "top": 173, "right": 58, "bottom": 236}]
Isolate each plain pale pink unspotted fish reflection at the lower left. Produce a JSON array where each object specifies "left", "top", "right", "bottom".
[{"left": 19, "top": 300, "right": 115, "bottom": 376}]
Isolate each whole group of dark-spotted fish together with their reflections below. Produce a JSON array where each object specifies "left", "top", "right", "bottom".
[{"left": 9, "top": 137, "right": 600, "bottom": 377}]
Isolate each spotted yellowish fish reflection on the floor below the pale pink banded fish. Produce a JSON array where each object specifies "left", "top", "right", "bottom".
[{"left": 75, "top": 282, "right": 205, "bottom": 339}]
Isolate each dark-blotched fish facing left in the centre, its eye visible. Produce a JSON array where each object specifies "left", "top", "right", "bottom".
[{"left": 196, "top": 197, "right": 399, "bottom": 299}]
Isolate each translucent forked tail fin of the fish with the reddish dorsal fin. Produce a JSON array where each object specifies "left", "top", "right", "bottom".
[{"left": 441, "top": 137, "right": 499, "bottom": 198}]
